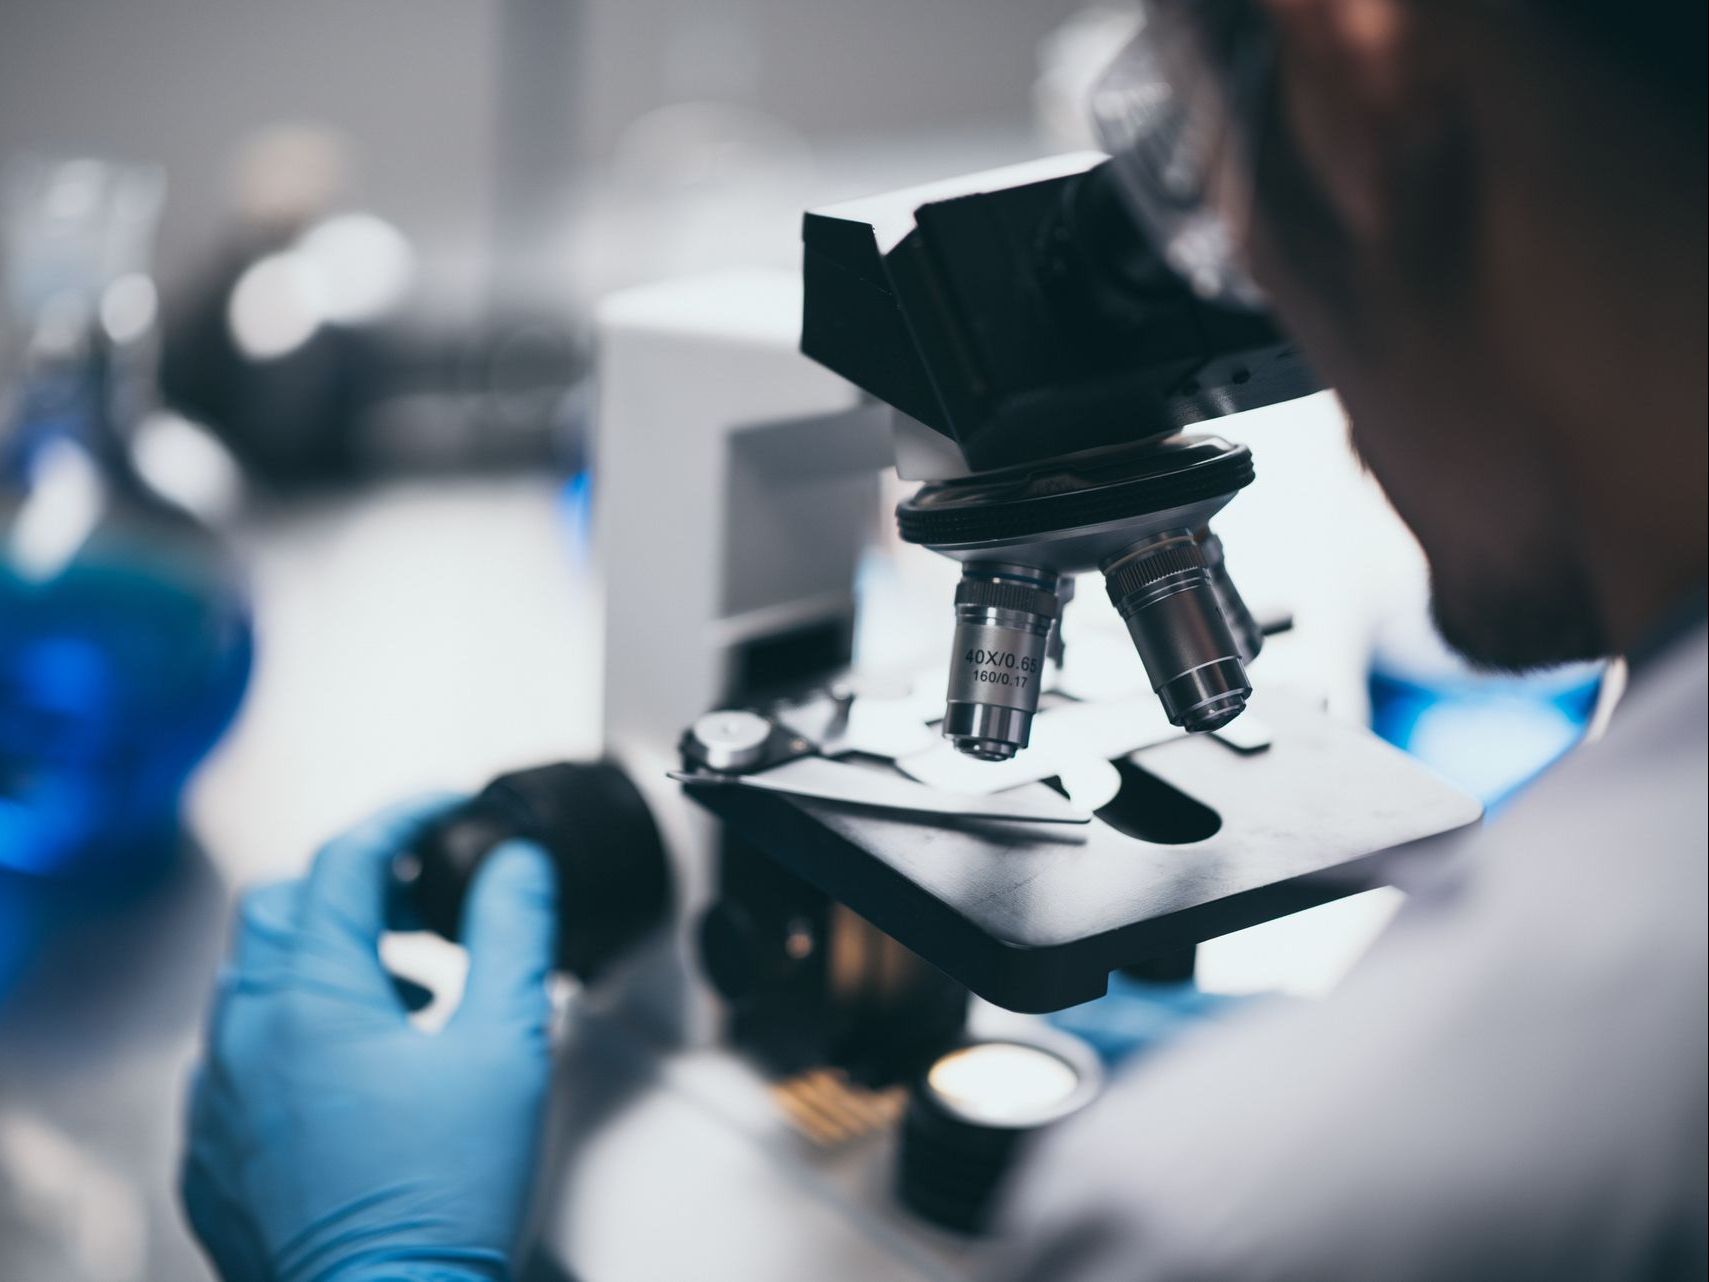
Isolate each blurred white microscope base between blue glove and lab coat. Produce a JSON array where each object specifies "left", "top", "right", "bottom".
[{"left": 545, "top": 1012, "right": 979, "bottom": 1282}]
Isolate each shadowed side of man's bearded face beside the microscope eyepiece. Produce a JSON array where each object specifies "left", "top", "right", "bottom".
[{"left": 1249, "top": 0, "right": 1606, "bottom": 668}]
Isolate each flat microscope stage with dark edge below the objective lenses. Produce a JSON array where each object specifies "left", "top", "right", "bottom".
[{"left": 692, "top": 692, "right": 1482, "bottom": 1012}]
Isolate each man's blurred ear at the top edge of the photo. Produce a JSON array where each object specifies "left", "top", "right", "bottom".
[{"left": 1260, "top": 0, "right": 1446, "bottom": 250}]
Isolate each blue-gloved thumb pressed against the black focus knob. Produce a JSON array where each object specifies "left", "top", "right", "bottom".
[{"left": 455, "top": 841, "right": 557, "bottom": 1032}]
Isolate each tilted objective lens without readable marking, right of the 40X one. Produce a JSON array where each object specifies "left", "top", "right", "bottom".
[{"left": 1104, "top": 530, "right": 1253, "bottom": 732}]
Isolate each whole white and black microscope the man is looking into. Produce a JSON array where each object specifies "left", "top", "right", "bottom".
[{"left": 415, "top": 154, "right": 1480, "bottom": 1282}]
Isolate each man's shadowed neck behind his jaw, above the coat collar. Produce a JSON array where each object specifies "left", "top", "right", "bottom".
[{"left": 1489, "top": 42, "right": 1709, "bottom": 653}]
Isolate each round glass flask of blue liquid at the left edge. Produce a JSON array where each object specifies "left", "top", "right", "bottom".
[{"left": 0, "top": 161, "right": 253, "bottom": 884}]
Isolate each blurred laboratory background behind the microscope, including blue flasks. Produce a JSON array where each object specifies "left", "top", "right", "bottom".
[{"left": 0, "top": 0, "right": 1601, "bottom": 1282}]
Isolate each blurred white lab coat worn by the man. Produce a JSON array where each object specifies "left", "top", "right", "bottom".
[{"left": 996, "top": 627, "right": 1709, "bottom": 1282}]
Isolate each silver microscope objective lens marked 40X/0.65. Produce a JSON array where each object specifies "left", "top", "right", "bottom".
[{"left": 943, "top": 564, "right": 1061, "bottom": 761}]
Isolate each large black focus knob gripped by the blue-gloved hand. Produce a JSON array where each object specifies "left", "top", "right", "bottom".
[{"left": 412, "top": 761, "right": 670, "bottom": 983}]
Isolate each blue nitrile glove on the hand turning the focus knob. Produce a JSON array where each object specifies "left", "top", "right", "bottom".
[{"left": 183, "top": 802, "right": 555, "bottom": 1282}]
